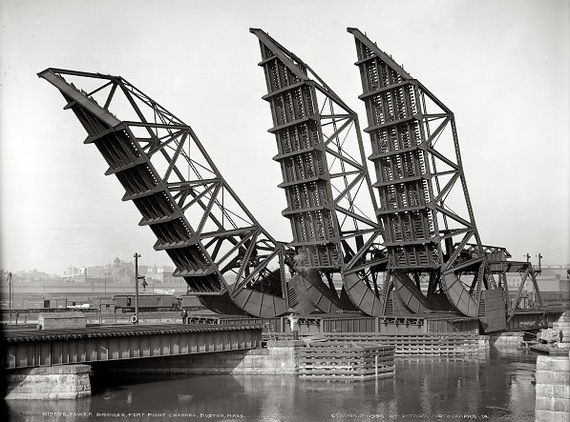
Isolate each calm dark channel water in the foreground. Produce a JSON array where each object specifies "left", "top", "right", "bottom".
[{"left": 9, "top": 352, "right": 536, "bottom": 422}]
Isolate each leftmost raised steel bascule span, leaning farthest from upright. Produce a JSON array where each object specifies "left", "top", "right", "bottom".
[{"left": 38, "top": 68, "right": 292, "bottom": 316}]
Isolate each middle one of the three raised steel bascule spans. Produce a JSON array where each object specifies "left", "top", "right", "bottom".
[{"left": 250, "top": 29, "right": 387, "bottom": 315}]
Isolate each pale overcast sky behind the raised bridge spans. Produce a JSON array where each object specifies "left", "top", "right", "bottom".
[{"left": 0, "top": 0, "right": 570, "bottom": 273}]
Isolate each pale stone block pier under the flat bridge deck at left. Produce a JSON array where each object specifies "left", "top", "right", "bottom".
[{"left": 6, "top": 365, "right": 91, "bottom": 400}]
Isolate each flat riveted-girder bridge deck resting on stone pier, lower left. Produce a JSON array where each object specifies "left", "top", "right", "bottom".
[{"left": 2, "top": 324, "right": 261, "bottom": 369}]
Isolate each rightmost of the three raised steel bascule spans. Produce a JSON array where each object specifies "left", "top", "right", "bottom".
[{"left": 348, "top": 28, "right": 496, "bottom": 316}]
